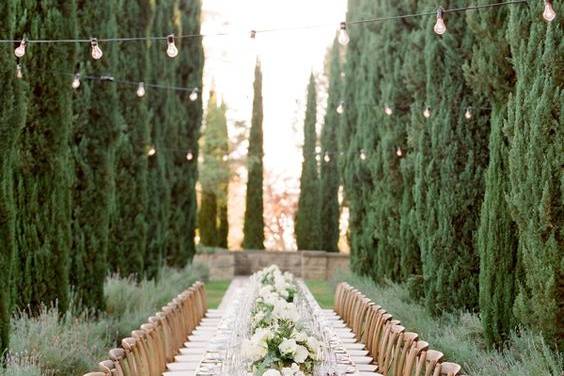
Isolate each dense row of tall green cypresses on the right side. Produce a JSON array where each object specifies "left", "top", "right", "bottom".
[{"left": 338, "top": 0, "right": 564, "bottom": 345}]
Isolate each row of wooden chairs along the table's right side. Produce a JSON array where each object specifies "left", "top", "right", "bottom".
[{"left": 335, "top": 283, "right": 461, "bottom": 376}]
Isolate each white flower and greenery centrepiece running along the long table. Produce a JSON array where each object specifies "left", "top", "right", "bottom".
[{"left": 243, "top": 266, "right": 321, "bottom": 376}]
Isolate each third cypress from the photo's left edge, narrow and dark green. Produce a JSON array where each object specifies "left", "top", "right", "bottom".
[{"left": 71, "top": 0, "right": 120, "bottom": 310}]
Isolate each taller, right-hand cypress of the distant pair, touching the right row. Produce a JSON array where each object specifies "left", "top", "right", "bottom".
[{"left": 319, "top": 39, "right": 342, "bottom": 252}]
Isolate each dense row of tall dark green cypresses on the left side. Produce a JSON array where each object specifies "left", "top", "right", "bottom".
[{"left": 0, "top": 0, "right": 203, "bottom": 352}]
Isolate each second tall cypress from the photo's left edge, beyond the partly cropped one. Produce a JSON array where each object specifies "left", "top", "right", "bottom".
[{"left": 15, "top": 0, "right": 76, "bottom": 312}]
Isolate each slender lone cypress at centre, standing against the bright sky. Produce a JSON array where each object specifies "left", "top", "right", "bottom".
[{"left": 243, "top": 61, "right": 264, "bottom": 249}]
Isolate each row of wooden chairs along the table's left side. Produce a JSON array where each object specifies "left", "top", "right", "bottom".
[{"left": 84, "top": 282, "right": 207, "bottom": 376}]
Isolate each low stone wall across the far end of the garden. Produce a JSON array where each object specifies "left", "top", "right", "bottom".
[{"left": 194, "top": 251, "right": 349, "bottom": 280}]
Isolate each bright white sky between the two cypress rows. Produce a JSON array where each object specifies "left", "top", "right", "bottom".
[{"left": 198, "top": 0, "right": 346, "bottom": 248}]
